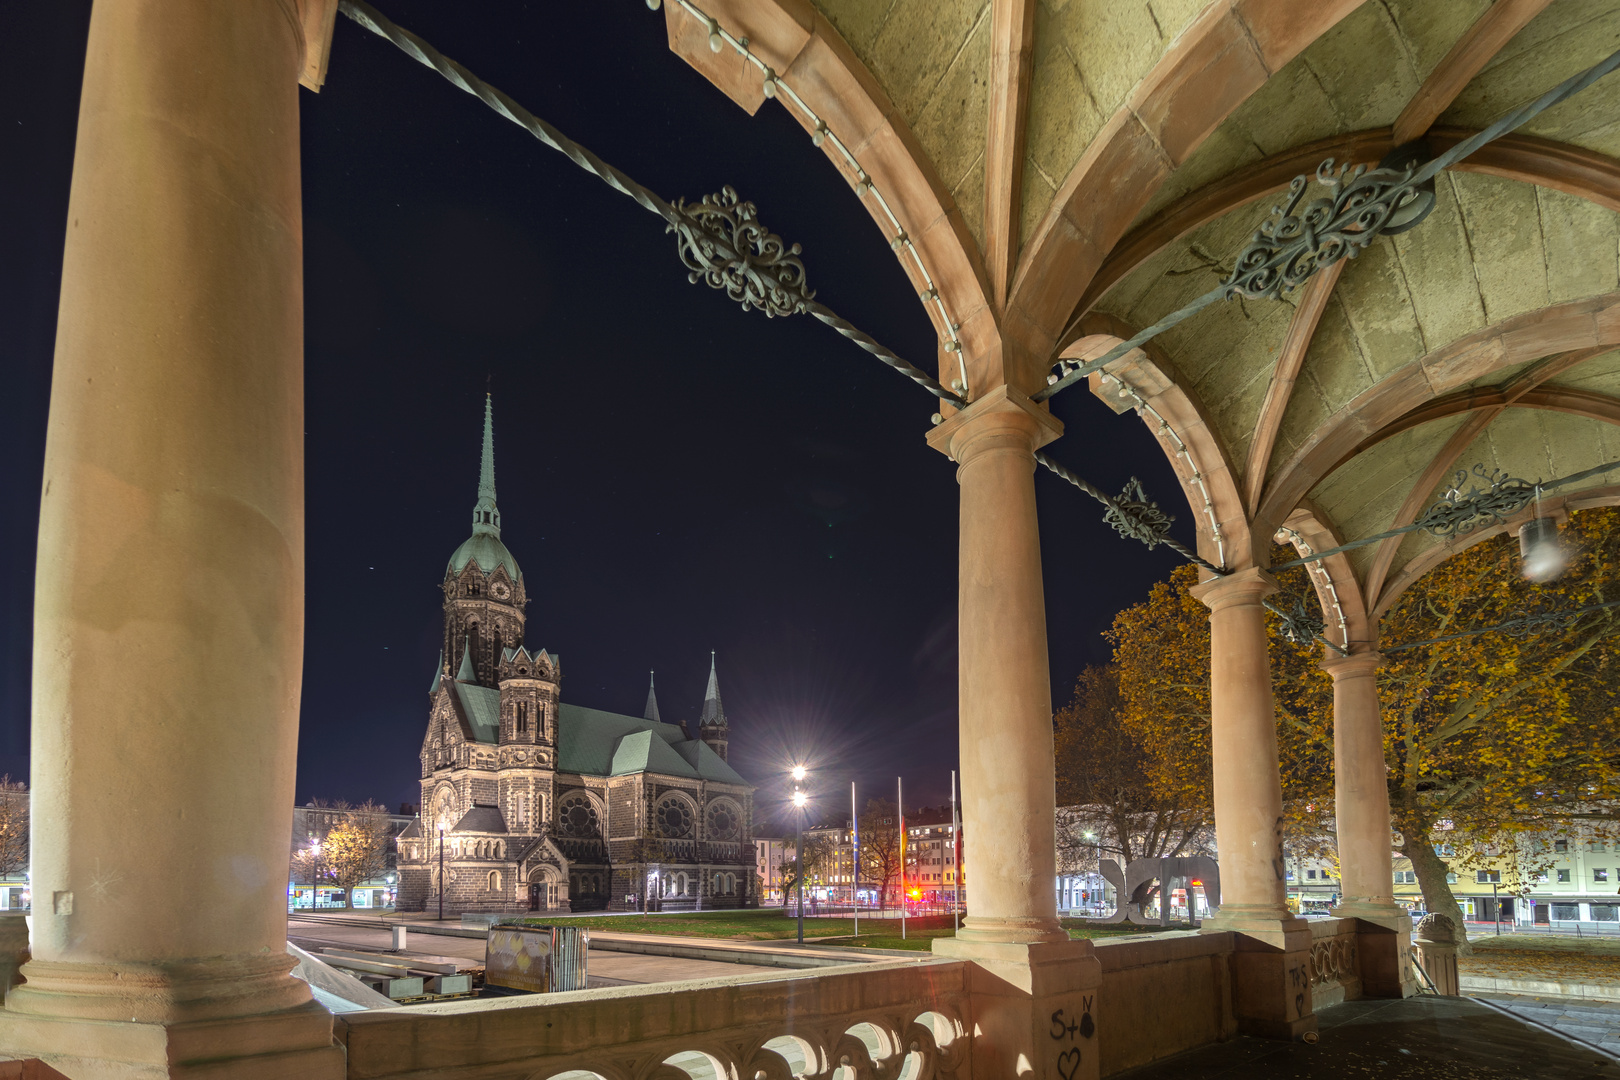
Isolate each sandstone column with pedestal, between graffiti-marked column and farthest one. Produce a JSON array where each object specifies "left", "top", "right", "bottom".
[{"left": 1192, "top": 568, "right": 1315, "bottom": 1038}]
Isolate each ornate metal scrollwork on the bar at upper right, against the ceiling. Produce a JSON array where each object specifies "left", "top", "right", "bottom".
[{"left": 1223, "top": 147, "right": 1434, "bottom": 300}]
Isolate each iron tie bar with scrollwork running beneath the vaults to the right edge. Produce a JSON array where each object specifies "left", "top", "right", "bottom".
[{"left": 1030, "top": 41, "right": 1620, "bottom": 402}]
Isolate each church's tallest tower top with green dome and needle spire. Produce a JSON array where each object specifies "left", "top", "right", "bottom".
[{"left": 441, "top": 393, "right": 528, "bottom": 687}]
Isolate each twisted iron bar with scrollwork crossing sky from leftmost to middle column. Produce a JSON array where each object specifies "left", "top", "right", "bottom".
[{"left": 339, "top": 0, "right": 967, "bottom": 408}]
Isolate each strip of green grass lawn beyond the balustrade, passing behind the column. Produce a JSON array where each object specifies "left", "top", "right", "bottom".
[{"left": 511, "top": 908, "right": 1198, "bottom": 952}]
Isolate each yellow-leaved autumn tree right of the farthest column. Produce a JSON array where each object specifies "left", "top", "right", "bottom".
[{"left": 1379, "top": 508, "right": 1620, "bottom": 945}]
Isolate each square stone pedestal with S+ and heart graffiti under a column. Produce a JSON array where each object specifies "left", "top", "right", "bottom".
[{"left": 933, "top": 938, "right": 1103, "bottom": 1080}]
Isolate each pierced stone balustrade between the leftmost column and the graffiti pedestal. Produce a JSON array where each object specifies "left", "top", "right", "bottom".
[{"left": 345, "top": 957, "right": 970, "bottom": 1080}]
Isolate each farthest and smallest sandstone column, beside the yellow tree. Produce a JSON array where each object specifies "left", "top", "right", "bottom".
[{"left": 1322, "top": 653, "right": 1403, "bottom": 918}]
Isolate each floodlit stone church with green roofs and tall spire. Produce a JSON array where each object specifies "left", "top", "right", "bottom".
[{"left": 399, "top": 397, "right": 758, "bottom": 912}]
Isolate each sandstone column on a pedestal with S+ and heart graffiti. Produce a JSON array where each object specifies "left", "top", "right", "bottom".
[{"left": 928, "top": 387, "right": 1102, "bottom": 1080}]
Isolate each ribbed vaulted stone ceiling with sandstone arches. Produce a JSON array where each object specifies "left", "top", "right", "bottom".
[{"left": 666, "top": 0, "right": 1620, "bottom": 640}]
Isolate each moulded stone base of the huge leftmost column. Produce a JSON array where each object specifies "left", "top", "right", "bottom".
[{"left": 0, "top": 954, "right": 347, "bottom": 1080}]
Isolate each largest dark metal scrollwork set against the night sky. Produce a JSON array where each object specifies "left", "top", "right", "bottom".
[{"left": 664, "top": 185, "right": 815, "bottom": 317}]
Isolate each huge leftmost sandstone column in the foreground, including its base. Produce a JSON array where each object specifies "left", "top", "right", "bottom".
[{"left": 0, "top": 0, "right": 343, "bottom": 1077}]
